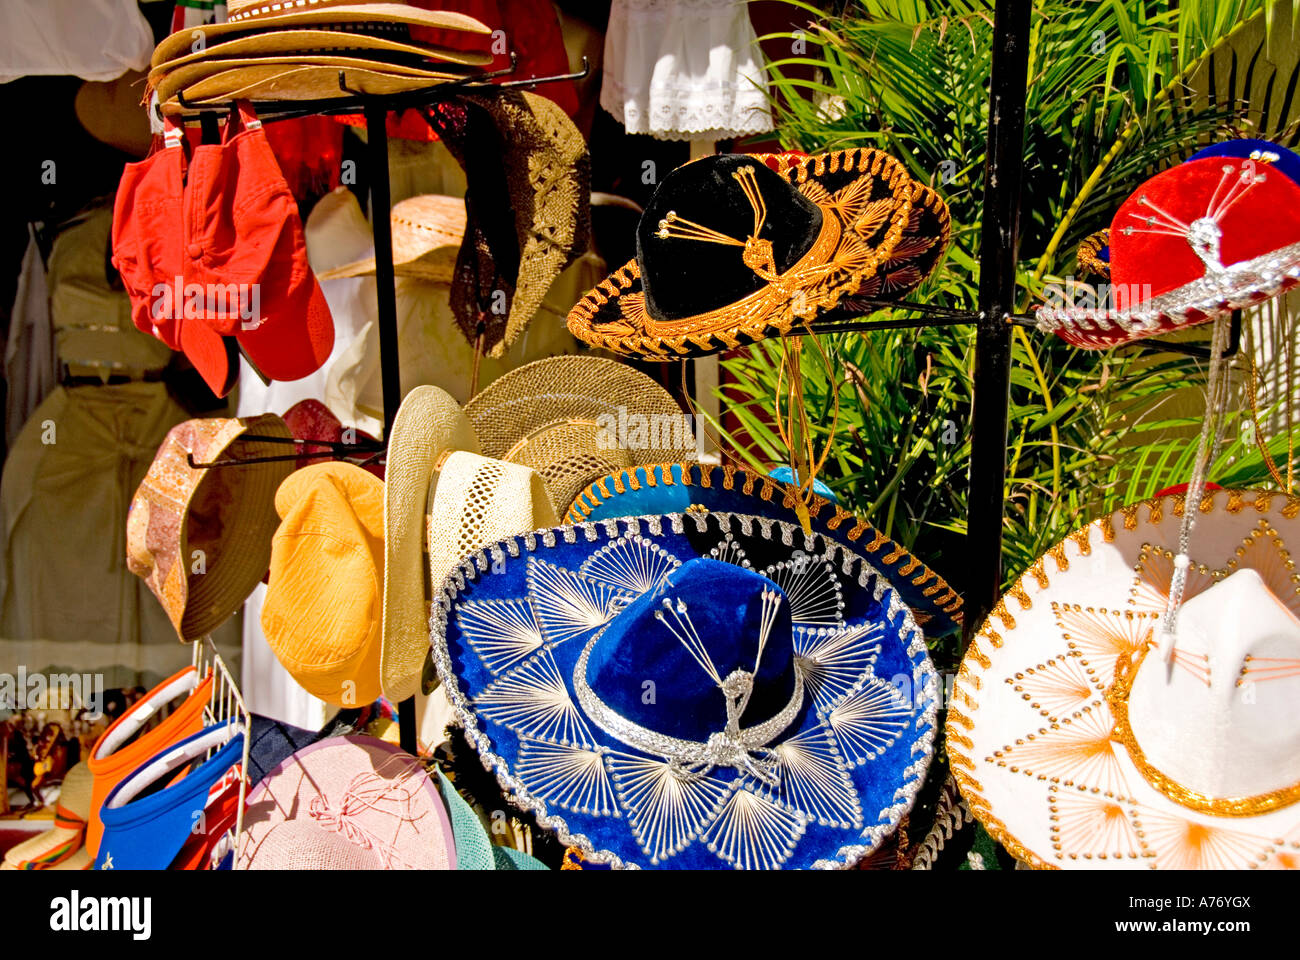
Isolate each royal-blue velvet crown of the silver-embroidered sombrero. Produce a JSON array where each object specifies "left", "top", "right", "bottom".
[{"left": 575, "top": 558, "right": 801, "bottom": 765}]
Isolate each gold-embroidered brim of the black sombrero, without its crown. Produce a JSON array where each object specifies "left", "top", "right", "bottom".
[{"left": 568, "top": 147, "right": 949, "bottom": 360}]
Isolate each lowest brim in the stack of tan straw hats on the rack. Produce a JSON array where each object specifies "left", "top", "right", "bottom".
[{"left": 163, "top": 66, "right": 455, "bottom": 113}]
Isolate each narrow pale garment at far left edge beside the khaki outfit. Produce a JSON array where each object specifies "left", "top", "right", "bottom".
[{"left": 4, "top": 224, "right": 59, "bottom": 446}]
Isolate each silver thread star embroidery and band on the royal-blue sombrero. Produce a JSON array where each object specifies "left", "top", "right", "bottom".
[{"left": 458, "top": 533, "right": 914, "bottom": 869}]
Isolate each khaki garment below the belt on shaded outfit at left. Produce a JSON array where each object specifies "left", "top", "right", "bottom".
[{"left": 0, "top": 384, "right": 190, "bottom": 688}]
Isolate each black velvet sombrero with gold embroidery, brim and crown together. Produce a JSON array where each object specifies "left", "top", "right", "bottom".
[{"left": 568, "top": 148, "right": 949, "bottom": 360}]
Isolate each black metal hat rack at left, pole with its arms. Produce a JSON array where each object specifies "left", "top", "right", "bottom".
[{"left": 156, "top": 52, "right": 590, "bottom": 754}]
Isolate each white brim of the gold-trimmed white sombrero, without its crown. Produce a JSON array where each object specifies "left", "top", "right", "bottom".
[{"left": 948, "top": 490, "right": 1300, "bottom": 869}]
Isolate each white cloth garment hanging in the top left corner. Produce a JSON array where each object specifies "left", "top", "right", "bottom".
[{"left": 0, "top": 0, "right": 153, "bottom": 83}]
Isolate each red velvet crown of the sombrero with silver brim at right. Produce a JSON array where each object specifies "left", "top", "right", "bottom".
[{"left": 1110, "top": 157, "right": 1300, "bottom": 310}]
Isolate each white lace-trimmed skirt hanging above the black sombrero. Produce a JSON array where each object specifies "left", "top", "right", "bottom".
[{"left": 601, "top": 0, "right": 772, "bottom": 140}]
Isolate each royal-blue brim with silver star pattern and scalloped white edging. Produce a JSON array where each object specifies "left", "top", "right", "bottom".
[{"left": 430, "top": 513, "right": 939, "bottom": 869}]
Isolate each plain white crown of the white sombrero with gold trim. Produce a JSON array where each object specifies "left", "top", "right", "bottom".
[{"left": 1128, "top": 568, "right": 1300, "bottom": 799}]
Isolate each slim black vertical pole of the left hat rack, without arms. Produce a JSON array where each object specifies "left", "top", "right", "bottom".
[{"left": 365, "top": 100, "right": 416, "bottom": 753}]
